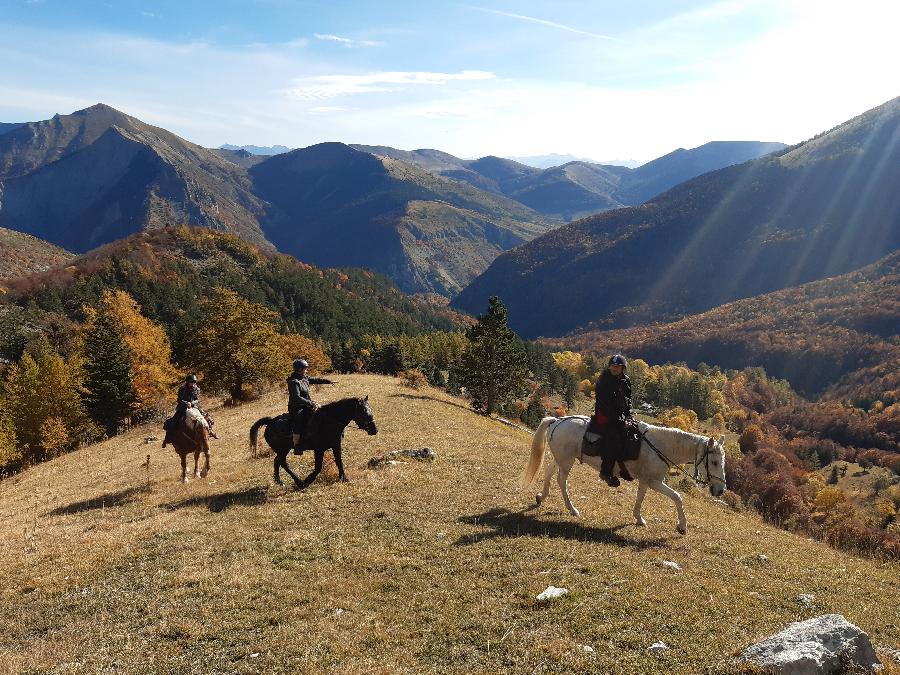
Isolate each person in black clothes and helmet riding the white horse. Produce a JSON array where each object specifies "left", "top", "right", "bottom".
[{"left": 592, "top": 354, "right": 631, "bottom": 487}]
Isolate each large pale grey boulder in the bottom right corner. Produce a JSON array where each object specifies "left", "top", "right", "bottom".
[{"left": 740, "top": 614, "right": 881, "bottom": 675}]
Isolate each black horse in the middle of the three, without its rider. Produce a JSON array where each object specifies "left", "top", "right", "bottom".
[{"left": 250, "top": 396, "right": 378, "bottom": 489}]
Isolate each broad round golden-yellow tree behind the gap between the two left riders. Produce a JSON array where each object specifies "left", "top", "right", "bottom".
[{"left": 189, "top": 288, "right": 291, "bottom": 400}]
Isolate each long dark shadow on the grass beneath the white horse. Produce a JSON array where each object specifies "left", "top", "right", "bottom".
[{"left": 454, "top": 507, "right": 668, "bottom": 550}]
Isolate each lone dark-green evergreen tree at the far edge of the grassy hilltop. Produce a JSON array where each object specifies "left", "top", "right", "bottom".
[{"left": 458, "top": 296, "right": 528, "bottom": 414}]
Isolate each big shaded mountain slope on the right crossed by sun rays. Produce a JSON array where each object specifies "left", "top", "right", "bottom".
[{"left": 454, "top": 98, "right": 900, "bottom": 337}]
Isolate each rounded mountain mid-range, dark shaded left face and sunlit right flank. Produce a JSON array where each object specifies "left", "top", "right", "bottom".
[{"left": 250, "top": 143, "right": 552, "bottom": 295}]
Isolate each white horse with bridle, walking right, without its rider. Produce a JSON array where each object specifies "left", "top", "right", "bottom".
[{"left": 522, "top": 415, "right": 725, "bottom": 534}]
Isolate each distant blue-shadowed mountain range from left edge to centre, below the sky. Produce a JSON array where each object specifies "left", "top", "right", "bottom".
[{"left": 0, "top": 104, "right": 780, "bottom": 296}]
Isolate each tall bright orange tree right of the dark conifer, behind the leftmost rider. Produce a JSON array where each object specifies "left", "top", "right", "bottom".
[{"left": 85, "top": 291, "right": 180, "bottom": 416}]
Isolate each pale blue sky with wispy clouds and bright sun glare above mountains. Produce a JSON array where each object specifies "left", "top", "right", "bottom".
[{"left": 0, "top": 0, "right": 900, "bottom": 161}]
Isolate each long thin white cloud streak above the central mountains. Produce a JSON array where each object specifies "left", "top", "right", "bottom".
[{"left": 282, "top": 70, "right": 494, "bottom": 100}]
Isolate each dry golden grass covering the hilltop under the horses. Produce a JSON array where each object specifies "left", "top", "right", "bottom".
[{"left": 0, "top": 375, "right": 900, "bottom": 673}]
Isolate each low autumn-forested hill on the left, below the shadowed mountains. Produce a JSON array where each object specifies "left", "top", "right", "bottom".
[{"left": 0, "top": 226, "right": 465, "bottom": 358}]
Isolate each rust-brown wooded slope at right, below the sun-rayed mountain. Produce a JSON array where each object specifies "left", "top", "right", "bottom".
[{"left": 553, "top": 252, "right": 900, "bottom": 396}]
